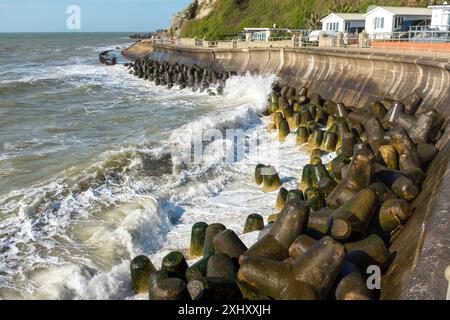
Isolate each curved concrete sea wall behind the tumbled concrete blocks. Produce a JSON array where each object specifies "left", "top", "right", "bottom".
[{"left": 124, "top": 40, "right": 450, "bottom": 299}]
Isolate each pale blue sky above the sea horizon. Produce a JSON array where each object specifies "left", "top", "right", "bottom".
[{"left": 0, "top": 0, "right": 191, "bottom": 33}]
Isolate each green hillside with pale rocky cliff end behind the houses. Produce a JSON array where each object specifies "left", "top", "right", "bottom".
[{"left": 172, "top": 0, "right": 433, "bottom": 40}]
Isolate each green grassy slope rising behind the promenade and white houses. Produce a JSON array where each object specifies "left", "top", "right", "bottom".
[{"left": 182, "top": 0, "right": 428, "bottom": 40}]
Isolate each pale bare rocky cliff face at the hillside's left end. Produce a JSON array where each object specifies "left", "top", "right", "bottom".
[{"left": 171, "top": 0, "right": 219, "bottom": 36}]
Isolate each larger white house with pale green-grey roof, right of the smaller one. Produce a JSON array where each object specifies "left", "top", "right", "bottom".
[{"left": 364, "top": 6, "right": 432, "bottom": 34}]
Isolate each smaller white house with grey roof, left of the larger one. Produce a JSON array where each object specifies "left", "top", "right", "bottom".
[{"left": 320, "top": 13, "right": 366, "bottom": 33}]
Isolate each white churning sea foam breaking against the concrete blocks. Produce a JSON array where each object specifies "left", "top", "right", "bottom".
[{"left": 0, "top": 71, "right": 326, "bottom": 299}]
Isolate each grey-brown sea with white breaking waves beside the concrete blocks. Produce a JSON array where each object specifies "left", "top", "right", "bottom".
[{"left": 0, "top": 33, "right": 320, "bottom": 300}]
